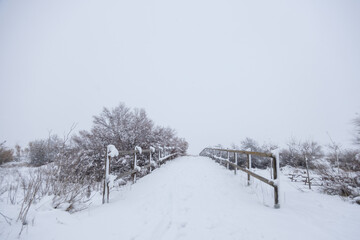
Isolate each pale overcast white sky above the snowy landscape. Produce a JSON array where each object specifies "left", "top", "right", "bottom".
[{"left": 0, "top": 0, "right": 360, "bottom": 153}]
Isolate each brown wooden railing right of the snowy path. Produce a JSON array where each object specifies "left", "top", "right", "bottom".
[{"left": 200, "top": 148, "right": 280, "bottom": 208}]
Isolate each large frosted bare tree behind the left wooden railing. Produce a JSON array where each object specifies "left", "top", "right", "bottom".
[{"left": 73, "top": 103, "right": 188, "bottom": 181}]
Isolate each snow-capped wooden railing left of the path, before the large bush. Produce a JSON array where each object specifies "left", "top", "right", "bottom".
[{"left": 102, "top": 147, "right": 179, "bottom": 204}]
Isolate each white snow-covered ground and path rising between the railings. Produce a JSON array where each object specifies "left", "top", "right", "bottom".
[{"left": 0, "top": 157, "right": 360, "bottom": 240}]
